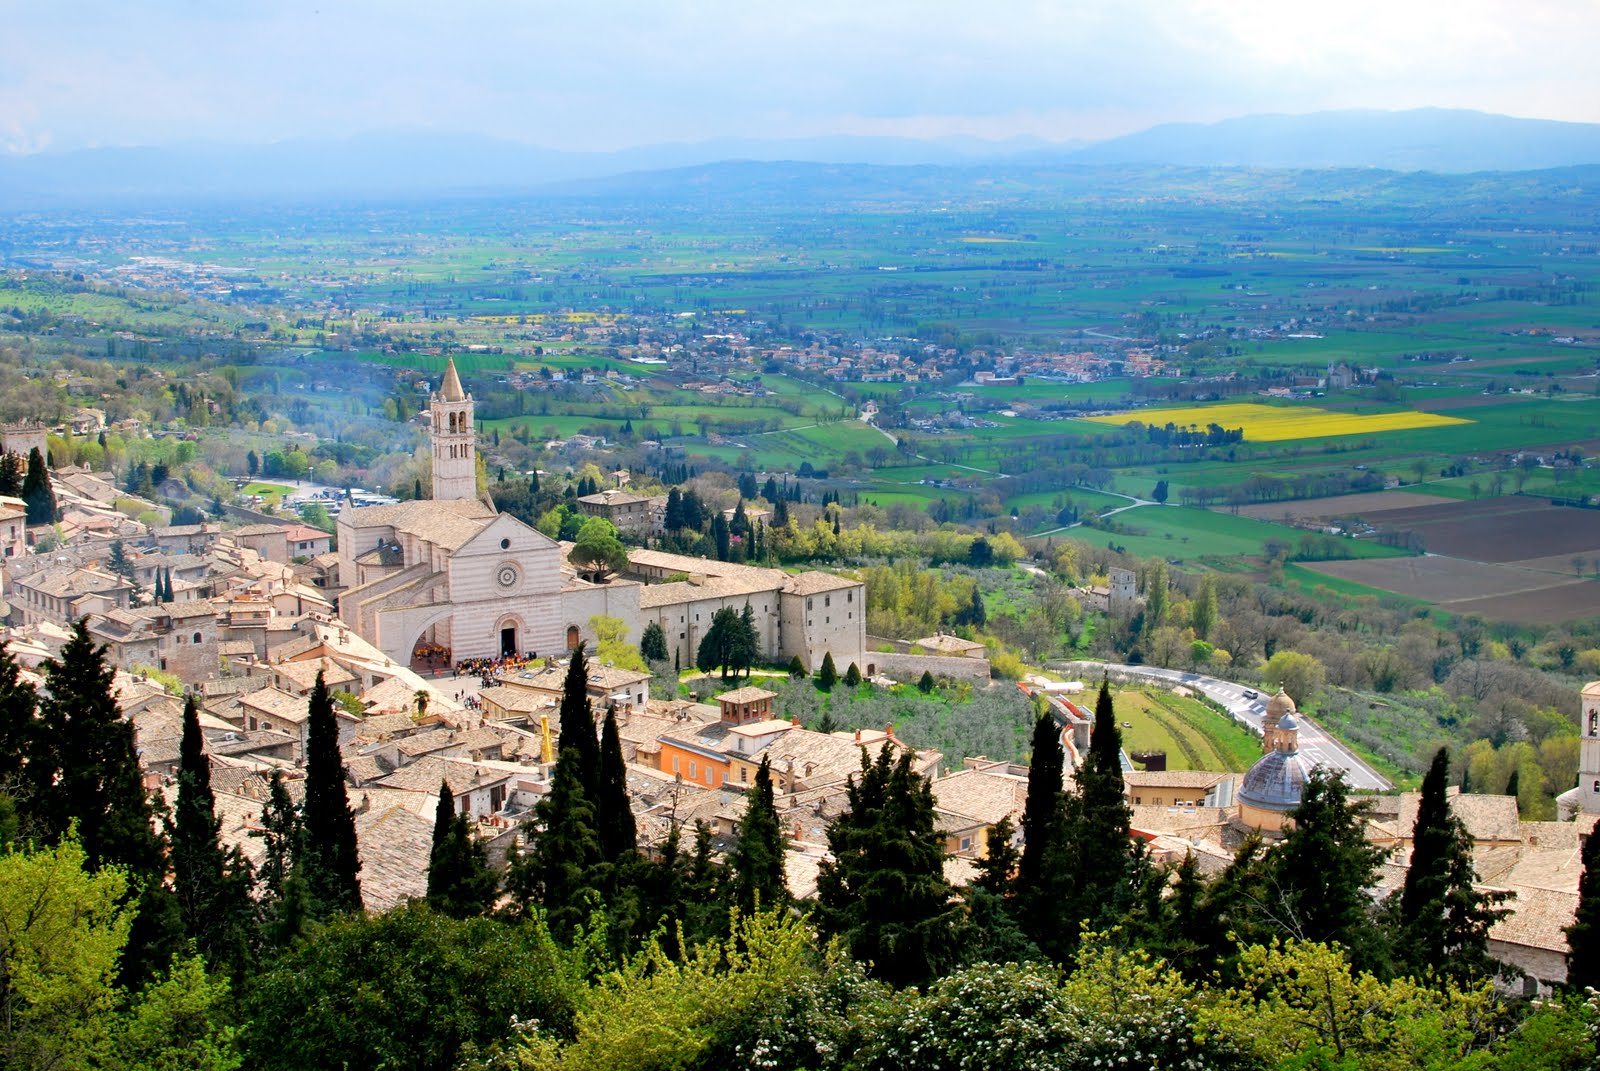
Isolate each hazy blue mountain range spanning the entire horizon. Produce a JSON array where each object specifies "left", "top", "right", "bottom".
[{"left": 0, "top": 109, "right": 1600, "bottom": 207}]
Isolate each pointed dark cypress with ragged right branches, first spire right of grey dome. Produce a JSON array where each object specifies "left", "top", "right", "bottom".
[{"left": 1395, "top": 748, "right": 1506, "bottom": 980}]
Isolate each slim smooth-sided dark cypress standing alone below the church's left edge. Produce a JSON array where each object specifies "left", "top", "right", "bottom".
[{"left": 301, "top": 671, "right": 362, "bottom": 914}]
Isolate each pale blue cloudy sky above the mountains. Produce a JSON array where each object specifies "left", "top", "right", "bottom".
[{"left": 0, "top": 0, "right": 1600, "bottom": 154}]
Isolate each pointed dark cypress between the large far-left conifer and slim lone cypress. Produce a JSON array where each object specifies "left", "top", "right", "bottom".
[{"left": 166, "top": 693, "right": 254, "bottom": 975}]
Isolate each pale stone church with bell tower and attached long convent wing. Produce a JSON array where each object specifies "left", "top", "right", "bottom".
[{"left": 338, "top": 362, "right": 877, "bottom": 676}]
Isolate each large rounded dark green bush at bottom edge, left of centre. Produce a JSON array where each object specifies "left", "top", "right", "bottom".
[{"left": 246, "top": 905, "right": 576, "bottom": 1071}]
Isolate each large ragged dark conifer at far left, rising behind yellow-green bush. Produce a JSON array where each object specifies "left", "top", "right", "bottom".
[{"left": 34, "top": 620, "right": 181, "bottom": 985}]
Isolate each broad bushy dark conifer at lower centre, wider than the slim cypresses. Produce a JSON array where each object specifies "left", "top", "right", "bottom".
[{"left": 816, "top": 746, "right": 960, "bottom": 986}]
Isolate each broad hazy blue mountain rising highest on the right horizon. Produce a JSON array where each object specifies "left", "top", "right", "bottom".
[{"left": 1070, "top": 107, "right": 1600, "bottom": 171}]
